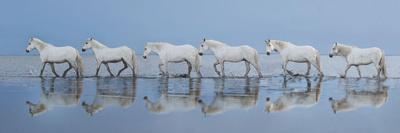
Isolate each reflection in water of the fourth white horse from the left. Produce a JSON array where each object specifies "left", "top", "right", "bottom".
[{"left": 198, "top": 78, "right": 260, "bottom": 116}]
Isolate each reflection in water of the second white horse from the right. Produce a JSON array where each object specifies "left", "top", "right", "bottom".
[{"left": 265, "top": 78, "right": 322, "bottom": 113}]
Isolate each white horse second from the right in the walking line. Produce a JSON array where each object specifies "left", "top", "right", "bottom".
[{"left": 265, "top": 40, "right": 324, "bottom": 76}]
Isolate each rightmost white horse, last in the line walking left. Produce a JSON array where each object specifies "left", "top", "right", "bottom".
[{"left": 329, "top": 43, "right": 387, "bottom": 79}]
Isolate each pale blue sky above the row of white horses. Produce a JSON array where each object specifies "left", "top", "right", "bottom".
[{"left": 0, "top": 0, "right": 400, "bottom": 55}]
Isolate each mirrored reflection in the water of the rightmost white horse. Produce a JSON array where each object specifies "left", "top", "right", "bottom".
[{"left": 329, "top": 83, "right": 388, "bottom": 113}]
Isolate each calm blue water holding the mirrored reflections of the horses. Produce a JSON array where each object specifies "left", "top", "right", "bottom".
[{"left": 0, "top": 56, "right": 400, "bottom": 133}]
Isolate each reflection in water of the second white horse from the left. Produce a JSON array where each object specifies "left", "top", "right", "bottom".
[{"left": 82, "top": 78, "right": 136, "bottom": 116}]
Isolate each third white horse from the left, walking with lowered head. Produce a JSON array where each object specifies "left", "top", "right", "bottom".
[{"left": 143, "top": 42, "right": 201, "bottom": 77}]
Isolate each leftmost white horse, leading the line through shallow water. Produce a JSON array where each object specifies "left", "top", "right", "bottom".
[{"left": 26, "top": 38, "right": 83, "bottom": 77}]
